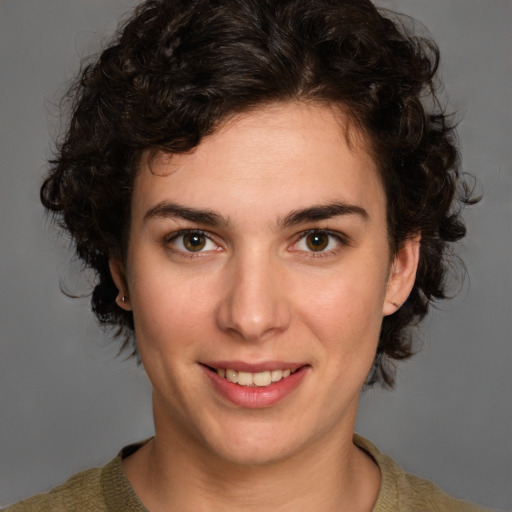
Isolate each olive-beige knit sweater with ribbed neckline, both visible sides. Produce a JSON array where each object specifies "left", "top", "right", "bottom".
[{"left": 4, "top": 435, "right": 492, "bottom": 512}]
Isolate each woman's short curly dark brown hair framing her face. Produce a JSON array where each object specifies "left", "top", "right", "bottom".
[{"left": 41, "top": 0, "right": 470, "bottom": 387}]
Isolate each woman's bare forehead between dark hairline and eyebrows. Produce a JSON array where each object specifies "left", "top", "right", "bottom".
[{"left": 133, "top": 103, "right": 385, "bottom": 225}]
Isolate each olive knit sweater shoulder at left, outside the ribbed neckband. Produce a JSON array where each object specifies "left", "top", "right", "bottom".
[{"left": 4, "top": 468, "right": 107, "bottom": 512}]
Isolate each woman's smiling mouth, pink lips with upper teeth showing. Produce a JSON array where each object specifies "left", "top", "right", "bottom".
[{"left": 201, "top": 361, "right": 310, "bottom": 408}]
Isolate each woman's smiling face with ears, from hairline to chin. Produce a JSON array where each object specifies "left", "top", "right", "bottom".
[{"left": 111, "top": 104, "right": 417, "bottom": 464}]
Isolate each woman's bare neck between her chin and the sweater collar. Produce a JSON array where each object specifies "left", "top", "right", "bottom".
[{"left": 124, "top": 410, "right": 380, "bottom": 512}]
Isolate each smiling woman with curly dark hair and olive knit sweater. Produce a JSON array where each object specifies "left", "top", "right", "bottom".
[{"left": 1, "top": 0, "right": 496, "bottom": 511}]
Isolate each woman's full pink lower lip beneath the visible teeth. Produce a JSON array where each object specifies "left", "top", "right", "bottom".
[{"left": 202, "top": 366, "right": 309, "bottom": 409}]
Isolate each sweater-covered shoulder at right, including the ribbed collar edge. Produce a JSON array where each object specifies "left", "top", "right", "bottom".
[{"left": 354, "top": 434, "right": 489, "bottom": 512}]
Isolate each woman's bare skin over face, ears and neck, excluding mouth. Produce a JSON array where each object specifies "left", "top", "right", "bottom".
[{"left": 111, "top": 103, "right": 419, "bottom": 512}]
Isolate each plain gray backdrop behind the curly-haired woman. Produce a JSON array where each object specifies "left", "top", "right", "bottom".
[{"left": 0, "top": 0, "right": 512, "bottom": 510}]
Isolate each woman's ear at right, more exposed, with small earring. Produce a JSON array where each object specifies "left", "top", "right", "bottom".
[{"left": 382, "top": 235, "right": 421, "bottom": 316}]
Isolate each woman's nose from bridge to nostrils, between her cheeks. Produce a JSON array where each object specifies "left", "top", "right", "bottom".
[{"left": 217, "top": 249, "right": 291, "bottom": 342}]
